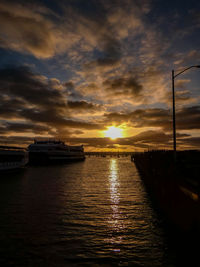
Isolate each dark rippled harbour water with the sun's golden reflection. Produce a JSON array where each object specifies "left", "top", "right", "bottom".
[{"left": 0, "top": 157, "right": 197, "bottom": 266}]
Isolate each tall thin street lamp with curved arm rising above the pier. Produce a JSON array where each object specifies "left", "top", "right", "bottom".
[{"left": 172, "top": 65, "right": 200, "bottom": 154}]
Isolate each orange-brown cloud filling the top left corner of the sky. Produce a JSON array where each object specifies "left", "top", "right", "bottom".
[{"left": 0, "top": 1, "right": 118, "bottom": 62}]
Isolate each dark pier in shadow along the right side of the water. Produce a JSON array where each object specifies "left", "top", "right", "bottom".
[{"left": 132, "top": 150, "right": 200, "bottom": 233}]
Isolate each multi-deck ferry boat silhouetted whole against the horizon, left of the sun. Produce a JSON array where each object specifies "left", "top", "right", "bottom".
[{"left": 28, "top": 140, "right": 85, "bottom": 164}]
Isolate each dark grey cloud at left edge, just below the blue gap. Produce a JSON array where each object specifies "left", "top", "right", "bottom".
[{"left": 0, "top": 67, "right": 66, "bottom": 108}]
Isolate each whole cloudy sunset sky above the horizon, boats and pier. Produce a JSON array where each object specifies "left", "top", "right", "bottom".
[{"left": 0, "top": 0, "right": 200, "bottom": 151}]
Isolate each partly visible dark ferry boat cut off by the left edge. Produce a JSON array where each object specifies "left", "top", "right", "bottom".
[{"left": 0, "top": 146, "right": 29, "bottom": 172}]
